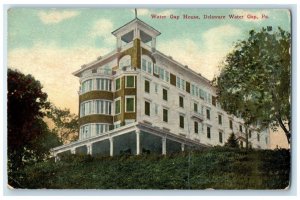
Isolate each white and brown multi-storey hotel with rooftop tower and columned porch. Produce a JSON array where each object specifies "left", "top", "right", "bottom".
[{"left": 52, "top": 18, "right": 270, "bottom": 159}]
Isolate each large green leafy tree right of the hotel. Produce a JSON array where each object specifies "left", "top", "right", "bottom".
[{"left": 216, "top": 27, "right": 291, "bottom": 143}]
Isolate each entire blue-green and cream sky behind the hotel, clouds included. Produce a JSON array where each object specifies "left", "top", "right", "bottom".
[{"left": 8, "top": 8, "right": 290, "bottom": 113}]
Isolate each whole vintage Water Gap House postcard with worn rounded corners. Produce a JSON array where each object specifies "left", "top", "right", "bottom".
[{"left": 7, "top": 7, "right": 292, "bottom": 190}]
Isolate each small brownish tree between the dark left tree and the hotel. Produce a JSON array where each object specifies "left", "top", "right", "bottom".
[{"left": 47, "top": 104, "right": 79, "bottom": 143}]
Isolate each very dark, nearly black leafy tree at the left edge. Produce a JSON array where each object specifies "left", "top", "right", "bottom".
[{"left": 7, "top": 69, "right": 60, "bottom": 187}]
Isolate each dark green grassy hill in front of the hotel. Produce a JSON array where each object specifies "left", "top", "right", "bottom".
[{"left": 18, "top": 147, "right": 290, "bottom": 189}]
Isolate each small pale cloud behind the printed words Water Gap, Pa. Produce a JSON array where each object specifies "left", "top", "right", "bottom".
[{"left": 232, "top": 9, "right": 270, "bottom": 22}]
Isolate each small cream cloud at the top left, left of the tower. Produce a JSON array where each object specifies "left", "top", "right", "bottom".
[{"left": 38, "top": 10, "right": 80, "bottom": 24}]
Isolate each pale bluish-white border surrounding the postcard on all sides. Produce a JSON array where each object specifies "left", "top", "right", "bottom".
[{"left": 0, "top": 0, "right": 299, "bottom": 200}]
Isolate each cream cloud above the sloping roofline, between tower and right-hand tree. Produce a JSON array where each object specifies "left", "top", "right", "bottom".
[{"left": 159, "top": 25, "right": 241, "bottom": 80}]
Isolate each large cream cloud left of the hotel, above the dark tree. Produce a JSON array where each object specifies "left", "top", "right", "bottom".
[{"left": 8, "top": 44, "right": 108, "bottom": 114}]
